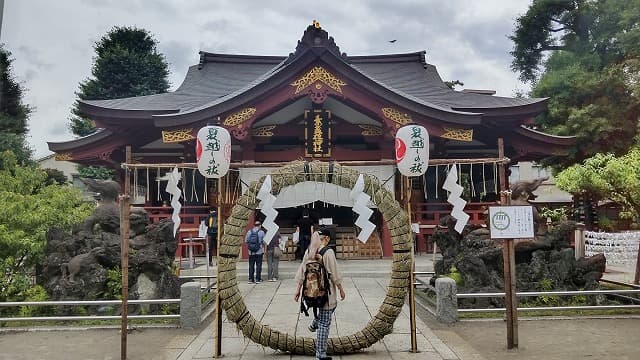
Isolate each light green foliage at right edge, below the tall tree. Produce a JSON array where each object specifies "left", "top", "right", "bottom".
[{"left": 556, "top": 147, "right": 640, "bottom": 223}]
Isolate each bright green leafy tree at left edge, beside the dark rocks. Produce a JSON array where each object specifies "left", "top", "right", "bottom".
[{"left": 0, "top": 151, "right": 92, "bottom": 301}]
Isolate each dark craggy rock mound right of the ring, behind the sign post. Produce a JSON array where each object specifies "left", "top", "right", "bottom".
[{"left": 433, "top": 219, "right": 605, "bottom": 307}]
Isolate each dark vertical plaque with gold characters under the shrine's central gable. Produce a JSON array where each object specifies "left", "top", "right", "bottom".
[{"left": 304, "top": 109, "right": 331, "bottom": 157}]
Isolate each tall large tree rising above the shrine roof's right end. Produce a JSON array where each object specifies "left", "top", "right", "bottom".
[{"left": 510, "top": 0, "right": 640, "bottom": 166}]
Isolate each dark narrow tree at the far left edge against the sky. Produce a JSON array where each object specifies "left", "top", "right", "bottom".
[{"left": 0, "top": 44, "right": 32, "bottom": 164}]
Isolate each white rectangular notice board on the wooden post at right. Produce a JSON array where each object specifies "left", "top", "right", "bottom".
[{"left": 489, "top": 206, "right": 535, "bottom": 239}]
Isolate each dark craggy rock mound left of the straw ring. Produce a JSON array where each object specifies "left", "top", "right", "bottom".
[{"left": 37, "top": 193, "right": 180, "bottom": 310}]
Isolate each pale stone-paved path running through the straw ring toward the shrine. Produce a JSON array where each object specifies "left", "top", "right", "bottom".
[{"left": 165, "top": 256, "right": 459, "bottom": 360}]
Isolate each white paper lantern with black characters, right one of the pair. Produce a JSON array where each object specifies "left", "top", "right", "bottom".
[{"left": 396, "top": 125, "right": 429, "bottom": 177}]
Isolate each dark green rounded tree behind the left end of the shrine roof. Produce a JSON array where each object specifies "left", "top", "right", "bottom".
[{"left": 70, "top": 27, "right": 169, "bottom": 136}]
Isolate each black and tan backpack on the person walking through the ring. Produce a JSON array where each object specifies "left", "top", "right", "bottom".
[{"left": 300, "top": 246, "right": 331, "bottom": 317}]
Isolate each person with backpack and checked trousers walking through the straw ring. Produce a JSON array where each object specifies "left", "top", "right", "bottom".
[{"left": 294, "top": 229, "right": 345, "bottom": 360}]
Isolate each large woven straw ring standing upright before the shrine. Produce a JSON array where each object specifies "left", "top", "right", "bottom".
[{"left": 218, "top": 161, "right": 411, "bottom": 355}]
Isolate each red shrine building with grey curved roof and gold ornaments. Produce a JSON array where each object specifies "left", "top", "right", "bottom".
[{"left": 49, "top": 21, "right": 574, "bottom": 258}]
